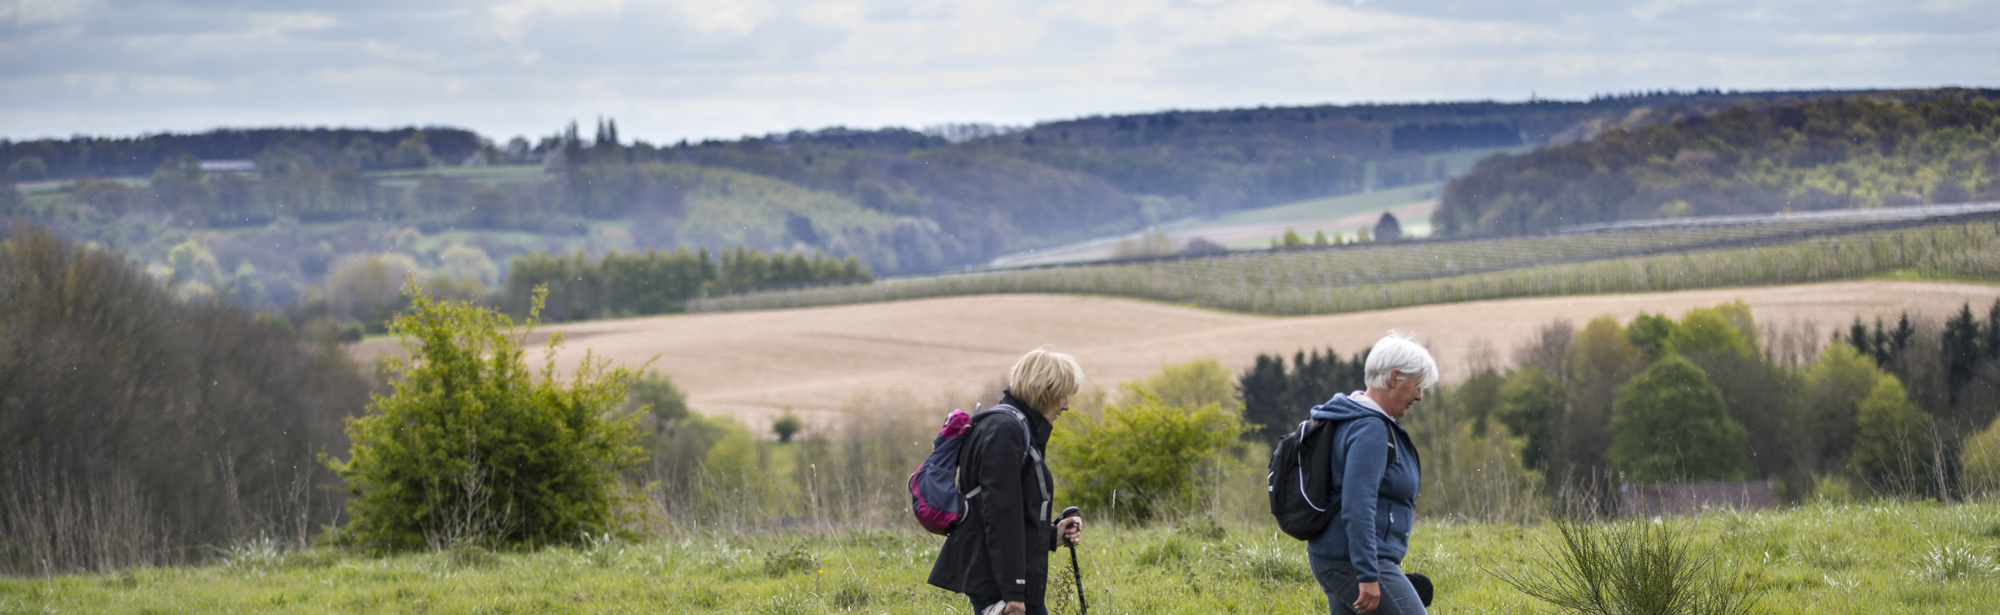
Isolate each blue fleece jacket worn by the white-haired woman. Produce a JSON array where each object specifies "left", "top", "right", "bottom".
[{"left": 1306, "top": 391, "right": 1424, "bottom": 583}]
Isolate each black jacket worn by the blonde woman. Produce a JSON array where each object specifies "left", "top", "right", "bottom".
[{"left": 930, "top": 395, "right": 1056, "bottom": 603}]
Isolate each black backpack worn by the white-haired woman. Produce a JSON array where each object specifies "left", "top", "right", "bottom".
[{"left": 1264, "top": 417, "right": 1396, "bottom": 541}]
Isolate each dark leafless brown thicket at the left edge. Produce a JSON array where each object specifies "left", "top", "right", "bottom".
[{"left": 0, "top": 226, "right": 370, "bottom": 575}]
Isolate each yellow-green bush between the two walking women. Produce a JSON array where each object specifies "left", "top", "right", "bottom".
[{"left": 1048, "top": 385, "right": 1244, "bottom": 523}]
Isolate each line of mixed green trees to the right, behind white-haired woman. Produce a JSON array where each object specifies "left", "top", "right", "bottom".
[{"left": 1236, "top": 302, "right": 2000, "bottom": 505}]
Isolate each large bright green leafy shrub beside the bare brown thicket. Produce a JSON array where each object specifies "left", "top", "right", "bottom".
[{"left": 330, "top": 288, "right": 644, "bottom": 551}]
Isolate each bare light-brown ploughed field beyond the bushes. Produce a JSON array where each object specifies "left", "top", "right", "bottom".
[{"left": 352, "top": 280, "right": 2000, "bottom": 431}]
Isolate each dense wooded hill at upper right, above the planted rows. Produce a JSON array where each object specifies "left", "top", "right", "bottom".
[{"left": 1434, "top": 90, "right": 2000, "bottom": 234}]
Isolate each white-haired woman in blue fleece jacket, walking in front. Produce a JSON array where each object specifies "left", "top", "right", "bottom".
[{"left": 1306, "top": 331, "right": 1438, "bottom": 615}]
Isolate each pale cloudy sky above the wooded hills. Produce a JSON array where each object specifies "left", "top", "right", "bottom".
[{"left": 0, "top": 0, "right": 2000, "bottom": 142}]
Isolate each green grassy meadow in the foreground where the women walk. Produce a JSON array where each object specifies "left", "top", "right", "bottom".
[{"left": 0, "top": 501, "right": 2000, "bottom": 615}]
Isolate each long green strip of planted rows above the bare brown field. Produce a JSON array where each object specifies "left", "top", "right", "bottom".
[{"left": 688, "top": 204, "right": 2000, "bottom": 315}]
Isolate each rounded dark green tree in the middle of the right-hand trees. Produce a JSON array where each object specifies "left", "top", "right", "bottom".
[{"left": 1610, "top": 355, "right": 1750, "bottom": 483}]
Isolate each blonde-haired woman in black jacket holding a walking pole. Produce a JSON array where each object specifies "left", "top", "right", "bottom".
[{"left": 930, "top": 347, "right": 1084, "bottom": 615}]
